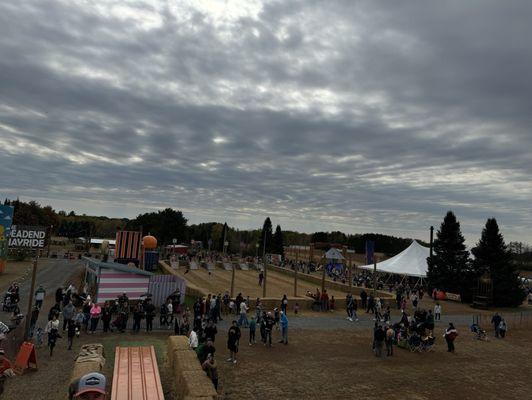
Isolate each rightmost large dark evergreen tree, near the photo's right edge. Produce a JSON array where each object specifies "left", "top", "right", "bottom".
[{"left": 472, "top": 218, "right": 525, "bottom": 307}]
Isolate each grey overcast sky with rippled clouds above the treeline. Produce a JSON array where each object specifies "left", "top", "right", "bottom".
[{"left": 0, "top": 0, "right": 532, "bottom": 245}]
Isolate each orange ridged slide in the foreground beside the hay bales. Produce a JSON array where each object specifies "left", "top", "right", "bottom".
[{"left": 111, "top": 346, "right": 164, "bottom": 400}]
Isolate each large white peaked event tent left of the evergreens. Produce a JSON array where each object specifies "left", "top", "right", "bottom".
[{"left": 358, "top": 240, "right": 430, "bottom": 278}]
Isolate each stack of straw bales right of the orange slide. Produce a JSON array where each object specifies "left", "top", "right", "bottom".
[{"left": 168, "top": 336, "right": 218, "bottom": 400}]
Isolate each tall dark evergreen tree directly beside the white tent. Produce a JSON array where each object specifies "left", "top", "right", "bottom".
[{"left": 427, "top": 211, "right": 472, "bottom": 301}]
